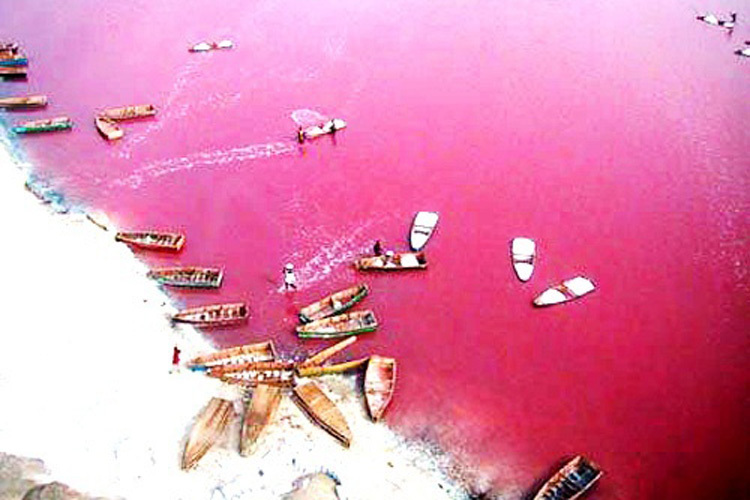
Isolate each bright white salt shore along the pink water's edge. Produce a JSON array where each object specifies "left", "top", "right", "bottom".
[{"left": 0, "top": 132, "right": 467, "bottom": 500}]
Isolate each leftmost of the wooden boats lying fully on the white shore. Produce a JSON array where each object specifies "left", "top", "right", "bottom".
[{"left": 182, "top": 398, "right": 234, "bottom": 470}]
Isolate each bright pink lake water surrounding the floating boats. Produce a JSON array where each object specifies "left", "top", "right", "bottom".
[{"left": 0, "top": 0, "right": 750, "bottom": 500}]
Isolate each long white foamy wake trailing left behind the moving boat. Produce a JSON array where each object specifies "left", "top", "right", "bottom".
[{"left": 110, "top": 142, "right": 297, "bottom": 189}]
